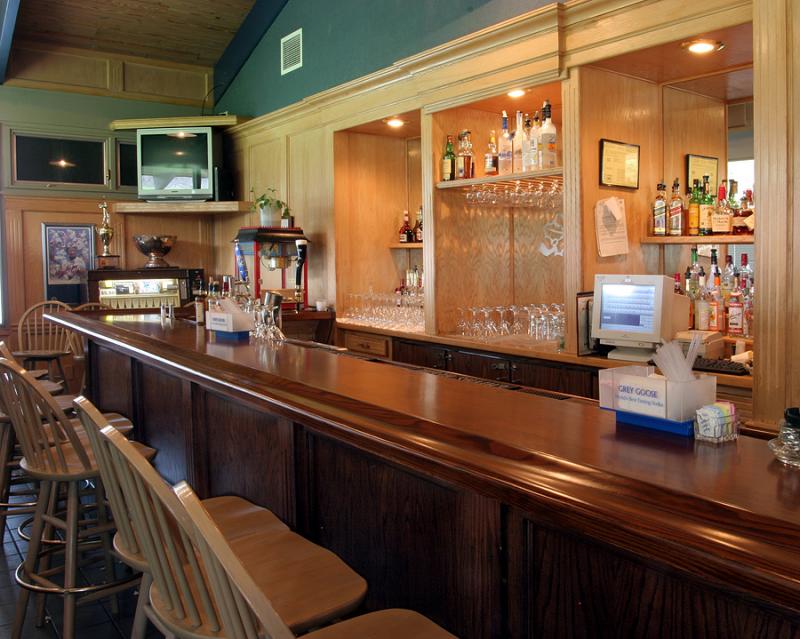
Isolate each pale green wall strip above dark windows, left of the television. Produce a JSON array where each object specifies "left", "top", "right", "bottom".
[{"left": 0, "top": 85, "right": 200, "bottom": 131}]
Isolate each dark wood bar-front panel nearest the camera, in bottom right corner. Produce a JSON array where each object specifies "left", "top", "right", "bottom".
[{"left": 507, "top": 512, "right": 800, "bottom": 639}]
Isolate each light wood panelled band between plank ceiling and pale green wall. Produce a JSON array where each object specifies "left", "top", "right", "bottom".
[{"left": 6, "top": 41, "right": 214, "bottom": 106}]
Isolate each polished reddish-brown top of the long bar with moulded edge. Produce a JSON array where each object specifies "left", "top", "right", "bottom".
[{"left": 50, "top": 313, "right": 800, "bottom": 607}]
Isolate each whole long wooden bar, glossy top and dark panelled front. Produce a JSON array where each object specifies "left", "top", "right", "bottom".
[{"left": 52, "top": 314, "right": 800, "bottom": 639}]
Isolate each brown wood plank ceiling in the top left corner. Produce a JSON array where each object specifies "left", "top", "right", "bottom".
[{"left": 14, "top": 0, "right": 255, "bottom": 67}]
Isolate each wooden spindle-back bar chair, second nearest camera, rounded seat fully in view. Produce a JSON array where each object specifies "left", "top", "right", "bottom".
[{"left": 101, "top": 420, "right": 366, "bottom": 638}]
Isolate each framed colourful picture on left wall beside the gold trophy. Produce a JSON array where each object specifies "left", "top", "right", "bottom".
[{"left": 42, "top": 222, "right": 95, "bottom": 304}]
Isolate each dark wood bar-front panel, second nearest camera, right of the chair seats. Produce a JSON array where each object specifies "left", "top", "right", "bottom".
[{"left": 308, "top": 434, "right": 503, "bottom": 639}]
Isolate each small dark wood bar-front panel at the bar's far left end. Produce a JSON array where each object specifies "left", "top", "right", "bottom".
[{"left": 87, "top": 341, "right": 135, "bottom": 419}]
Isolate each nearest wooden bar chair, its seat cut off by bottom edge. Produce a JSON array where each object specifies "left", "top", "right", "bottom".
[{"left": 177, "top": 482, "right": 454, "bottom": 639}]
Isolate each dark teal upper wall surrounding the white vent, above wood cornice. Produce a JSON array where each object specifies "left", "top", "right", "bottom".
[{"left": 216, "top": 0, "right": 553, "bottom": 116}]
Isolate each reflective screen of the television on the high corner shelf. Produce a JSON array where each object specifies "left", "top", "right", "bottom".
[{"left": 139, "top": 131, "right": 209, "bottom": 193}]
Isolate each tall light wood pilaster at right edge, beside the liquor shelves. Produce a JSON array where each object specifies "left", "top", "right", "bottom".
[{"left": 753, "top": 0, "right": 800, "bottom": 422}]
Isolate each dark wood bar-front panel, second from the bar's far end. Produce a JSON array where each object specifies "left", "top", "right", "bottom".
[{"left": 137, "top": 365, "right": 193, "bottom": 484}]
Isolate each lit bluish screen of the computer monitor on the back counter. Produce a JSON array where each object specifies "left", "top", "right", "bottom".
[{"left": 600, "top": 284, "right": 656, "bottom": 334}]
